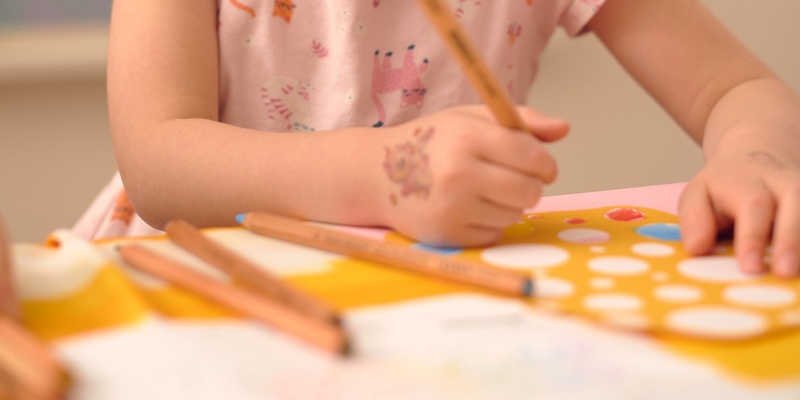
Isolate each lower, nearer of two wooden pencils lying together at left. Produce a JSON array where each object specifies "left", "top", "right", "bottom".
[{"left": 118, "top": 244, "right": 349, "bottom": 354}]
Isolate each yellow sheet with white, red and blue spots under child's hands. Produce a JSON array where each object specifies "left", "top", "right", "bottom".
[{"left": 400, "top": 207, "right": 800, "bottom": 341}]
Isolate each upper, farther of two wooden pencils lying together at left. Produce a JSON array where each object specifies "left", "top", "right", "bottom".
[{"left": 165, "top": 220, "right": 340, "bottom": 325}]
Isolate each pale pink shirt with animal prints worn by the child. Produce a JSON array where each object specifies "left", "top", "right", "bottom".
[{"left": 75, "top": 0, "right": 604, "bottom": 238}]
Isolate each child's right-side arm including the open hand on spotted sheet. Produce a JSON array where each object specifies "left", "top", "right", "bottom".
[{"left": 590, "top": 0, "right": 800, "bottom": 276}]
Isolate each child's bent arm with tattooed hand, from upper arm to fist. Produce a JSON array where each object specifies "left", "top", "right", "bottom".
[{"left": 108, "top": 0, "right": 568, "bottom": 245}]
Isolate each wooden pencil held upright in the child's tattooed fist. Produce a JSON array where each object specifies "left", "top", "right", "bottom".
[{"left": 419, "top": 0, "right": 525, "bottom": 130}]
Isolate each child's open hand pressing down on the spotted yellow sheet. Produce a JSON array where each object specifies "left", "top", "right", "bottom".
[{"left": 680, "top": 152, "right": 800, "bottom": 277}]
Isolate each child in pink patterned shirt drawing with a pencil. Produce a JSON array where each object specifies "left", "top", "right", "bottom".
[{"left": 77, "top": 0, "right": 800, "bottom": 277}]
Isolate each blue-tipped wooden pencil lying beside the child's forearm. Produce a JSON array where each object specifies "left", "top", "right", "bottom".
[{"left": 237, "top": 211, "right": 533, "bottom": 296}]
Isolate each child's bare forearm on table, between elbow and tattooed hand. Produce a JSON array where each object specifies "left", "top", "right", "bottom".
[{"left": 117, "top": 119, "right": 396, "bottom": 228}]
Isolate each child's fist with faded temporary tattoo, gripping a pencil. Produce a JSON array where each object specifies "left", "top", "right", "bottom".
[{"left": 384, "top": 106, "right": 569, "bottom": 246}]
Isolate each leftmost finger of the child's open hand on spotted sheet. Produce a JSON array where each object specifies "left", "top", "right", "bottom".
[{"left": 678, "top": 182, "right": 720, "bottom": 256}]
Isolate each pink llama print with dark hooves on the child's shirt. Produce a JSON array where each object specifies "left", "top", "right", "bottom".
[{"left": 371, "top": 44, "right": 428, "bottom": 128}]
